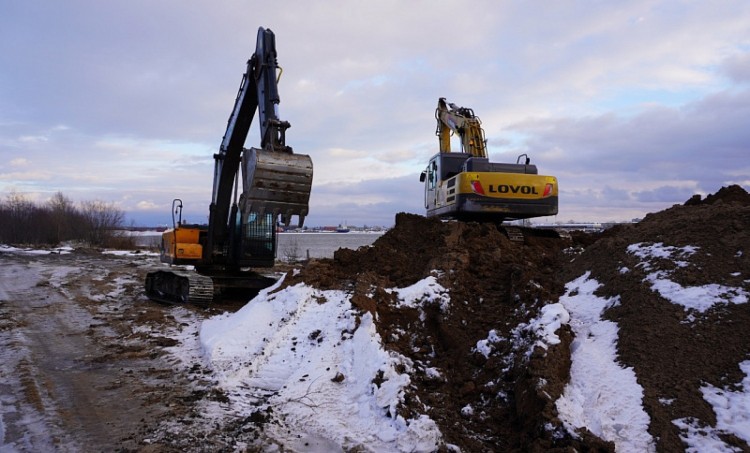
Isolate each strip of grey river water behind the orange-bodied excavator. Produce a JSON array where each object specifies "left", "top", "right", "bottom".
[{"left": 135, "top": 232, "right": 383, "bottom": 261}]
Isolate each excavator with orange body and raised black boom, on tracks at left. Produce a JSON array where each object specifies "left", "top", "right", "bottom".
[{"left": 145, "top": 27, "right": 313, "bottom": 305}]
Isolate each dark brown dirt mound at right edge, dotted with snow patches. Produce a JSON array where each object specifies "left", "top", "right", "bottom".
[{"left": 565, "top": 186, "right": 750, "bottom": 451}]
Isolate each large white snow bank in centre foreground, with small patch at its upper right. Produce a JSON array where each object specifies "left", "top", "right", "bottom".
[{"left": 200, "top": 278, "right": 442, "bottom": 452}]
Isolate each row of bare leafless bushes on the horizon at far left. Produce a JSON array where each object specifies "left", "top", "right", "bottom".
[{"left": 0, "top": 192, "right": 128, "bottom": 247}]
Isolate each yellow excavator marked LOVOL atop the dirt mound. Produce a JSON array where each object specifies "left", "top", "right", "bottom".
[{"left": 420, "top": 98, "right": 558, "bottom": 224}]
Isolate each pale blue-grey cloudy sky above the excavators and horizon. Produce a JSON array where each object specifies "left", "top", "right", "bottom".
[{"left": 0, "top": 0, "right": 750, "bottom": 226}]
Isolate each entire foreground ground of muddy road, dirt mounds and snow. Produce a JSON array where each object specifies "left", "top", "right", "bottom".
[{"left": 0, "top": 185, "right": 750, "bottom": 453}]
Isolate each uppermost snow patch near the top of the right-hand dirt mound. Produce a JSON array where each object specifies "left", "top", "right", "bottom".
[{"left": 627, "top": 242, "right": 748, "bottom": 313}]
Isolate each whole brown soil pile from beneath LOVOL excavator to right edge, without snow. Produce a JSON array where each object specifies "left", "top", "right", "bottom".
[{"left": 287, "top": 186, "right": 750, "bottom": 451}]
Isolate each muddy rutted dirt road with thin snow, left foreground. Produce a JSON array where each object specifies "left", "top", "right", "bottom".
[{"left": 0, "top": 252, "right": 213, "bottom": 451}]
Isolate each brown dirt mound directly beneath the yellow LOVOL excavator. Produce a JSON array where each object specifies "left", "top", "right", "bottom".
[{"left": 287, "top": 213, "right": 604, "bottom": 451}]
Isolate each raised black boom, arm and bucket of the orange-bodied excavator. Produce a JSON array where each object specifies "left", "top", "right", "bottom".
[{"left": 202, "top": 27, "right": 312, "bottom": 267}]
